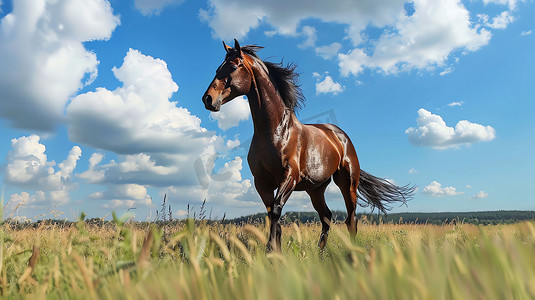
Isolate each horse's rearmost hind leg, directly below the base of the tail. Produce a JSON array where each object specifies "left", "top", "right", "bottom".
[{"left": 333, "top": 168, "right": 360, "bottom": 238}]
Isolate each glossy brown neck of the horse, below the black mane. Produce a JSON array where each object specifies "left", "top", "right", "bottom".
[{"left": 247, "top": 67, "right": 299, "bottom": 137}]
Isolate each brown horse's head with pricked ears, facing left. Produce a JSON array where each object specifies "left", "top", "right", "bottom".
[{"left": 202, "top": 40, "right": 252, "bottom": 111}]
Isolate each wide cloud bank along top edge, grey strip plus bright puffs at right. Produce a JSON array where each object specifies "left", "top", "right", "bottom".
[{"left": 199, "top": 0, "right": 502, "bottom": 76}]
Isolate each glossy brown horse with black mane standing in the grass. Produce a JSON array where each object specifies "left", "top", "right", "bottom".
[{"left": 202, "top": 40, "right": 414, "bottom": 251}]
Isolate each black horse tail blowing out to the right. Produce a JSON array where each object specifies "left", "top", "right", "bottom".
[{"left": 357, "top": 170, "right": 416, "bottom": 213}]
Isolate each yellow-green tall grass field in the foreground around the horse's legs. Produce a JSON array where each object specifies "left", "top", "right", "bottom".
[{"left": 0, "top": 214, "right": 535, "bottom": 299}]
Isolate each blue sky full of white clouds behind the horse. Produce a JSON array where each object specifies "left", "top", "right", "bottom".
[{"left": 0, "top": 0, "right": 535, "bottom": 221}]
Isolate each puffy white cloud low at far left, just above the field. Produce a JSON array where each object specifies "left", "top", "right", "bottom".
[{"left": 4, "top": 135, "right": 82, "bottom": 203}]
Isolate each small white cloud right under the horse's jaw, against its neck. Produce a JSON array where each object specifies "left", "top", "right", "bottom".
[{"left": 210, "top": 96, "right": 251, "bottom": 130}]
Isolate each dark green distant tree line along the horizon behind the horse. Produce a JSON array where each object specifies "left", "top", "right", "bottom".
[{"left": 228, "top": 210, "right": 535, "bottom": 225}]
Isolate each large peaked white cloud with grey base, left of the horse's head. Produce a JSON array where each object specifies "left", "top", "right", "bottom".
[{"left": 67, "top": 49, "right": 216, "bottom": 154}]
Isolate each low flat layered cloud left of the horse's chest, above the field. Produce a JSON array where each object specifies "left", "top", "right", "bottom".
[{"left": 74, "top": 150, "right": 255, "bottom": 215}]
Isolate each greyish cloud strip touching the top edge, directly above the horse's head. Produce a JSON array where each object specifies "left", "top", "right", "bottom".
[{"left": 200, "top": 0, "right": 404, "bottom": 40}]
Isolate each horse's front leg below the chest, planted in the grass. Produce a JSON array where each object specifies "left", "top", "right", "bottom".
[{"left": 267, "top": 168, "right": 298, "bottom": 252}]
